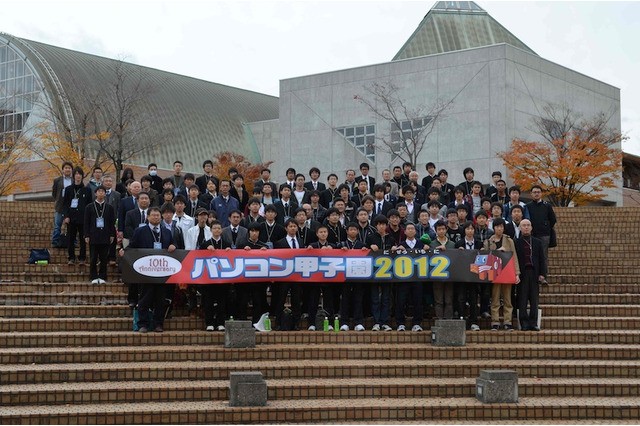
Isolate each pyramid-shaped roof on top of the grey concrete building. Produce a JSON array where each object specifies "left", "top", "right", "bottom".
[{"left": 393, "top": 1, "right": 536, "bottom": 61}]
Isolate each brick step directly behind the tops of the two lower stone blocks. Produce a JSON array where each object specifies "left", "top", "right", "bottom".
[{"left": 0, "top": 359, "right": 640, "bottom": 385}]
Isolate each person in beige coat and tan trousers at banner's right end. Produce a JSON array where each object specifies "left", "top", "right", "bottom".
[{"left": 484, "top": 218, "right": 520, "bottom": 331}]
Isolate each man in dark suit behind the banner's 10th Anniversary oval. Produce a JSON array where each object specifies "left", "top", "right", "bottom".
[{"left": 120, "top": 207, "right": 176, "bottom": 333}]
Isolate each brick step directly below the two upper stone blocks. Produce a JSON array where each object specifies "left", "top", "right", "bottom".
[{"left": 0, "top": 342, "right": 640, "bottom": 365}]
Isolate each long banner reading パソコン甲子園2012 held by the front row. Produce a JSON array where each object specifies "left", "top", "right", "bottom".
[{"left": 122, "top": 249, "right": 515, "bottom": 284}]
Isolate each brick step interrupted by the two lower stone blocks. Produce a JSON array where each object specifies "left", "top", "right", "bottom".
[{"left": 0, "top": 377, "right": 640, "bottom": 406}]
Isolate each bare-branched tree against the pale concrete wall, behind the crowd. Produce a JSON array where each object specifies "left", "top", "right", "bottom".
[{"left": 355, "top": 80, "right": 453, "bottom": 168}]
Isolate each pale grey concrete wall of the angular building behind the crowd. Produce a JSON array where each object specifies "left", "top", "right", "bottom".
[{"left": 258, "top": 44, "right": 622, "bottom": 205}]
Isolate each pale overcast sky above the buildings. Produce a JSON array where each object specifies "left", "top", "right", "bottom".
[{"left": 0, "top": 0, "right": 640, "bottom": 155}]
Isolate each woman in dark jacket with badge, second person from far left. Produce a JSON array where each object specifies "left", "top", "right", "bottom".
[{"left": 63, "top": 167, "right": 93, "bottom": 265}]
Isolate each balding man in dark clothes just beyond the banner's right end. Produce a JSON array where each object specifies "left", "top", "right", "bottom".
[{"left": 515, "top": 219, "right": 547, "bottom": 331}]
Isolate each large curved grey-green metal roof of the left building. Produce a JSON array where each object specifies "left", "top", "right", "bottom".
[{"left": 3, "top": 34, "right": 278, "bottom": 172}]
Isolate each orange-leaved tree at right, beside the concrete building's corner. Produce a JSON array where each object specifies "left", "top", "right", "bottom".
[{"left": 498, "top": 104, "right": 626, "bottom": 207}]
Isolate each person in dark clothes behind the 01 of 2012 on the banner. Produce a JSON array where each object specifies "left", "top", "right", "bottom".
[{"left": 396, "top": 222, "right": 424, "bottom": 332}]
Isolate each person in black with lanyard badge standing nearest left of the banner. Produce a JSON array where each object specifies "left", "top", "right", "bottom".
[{"left": 84, "top": 185, "right": 116, "bottom": 284}]
